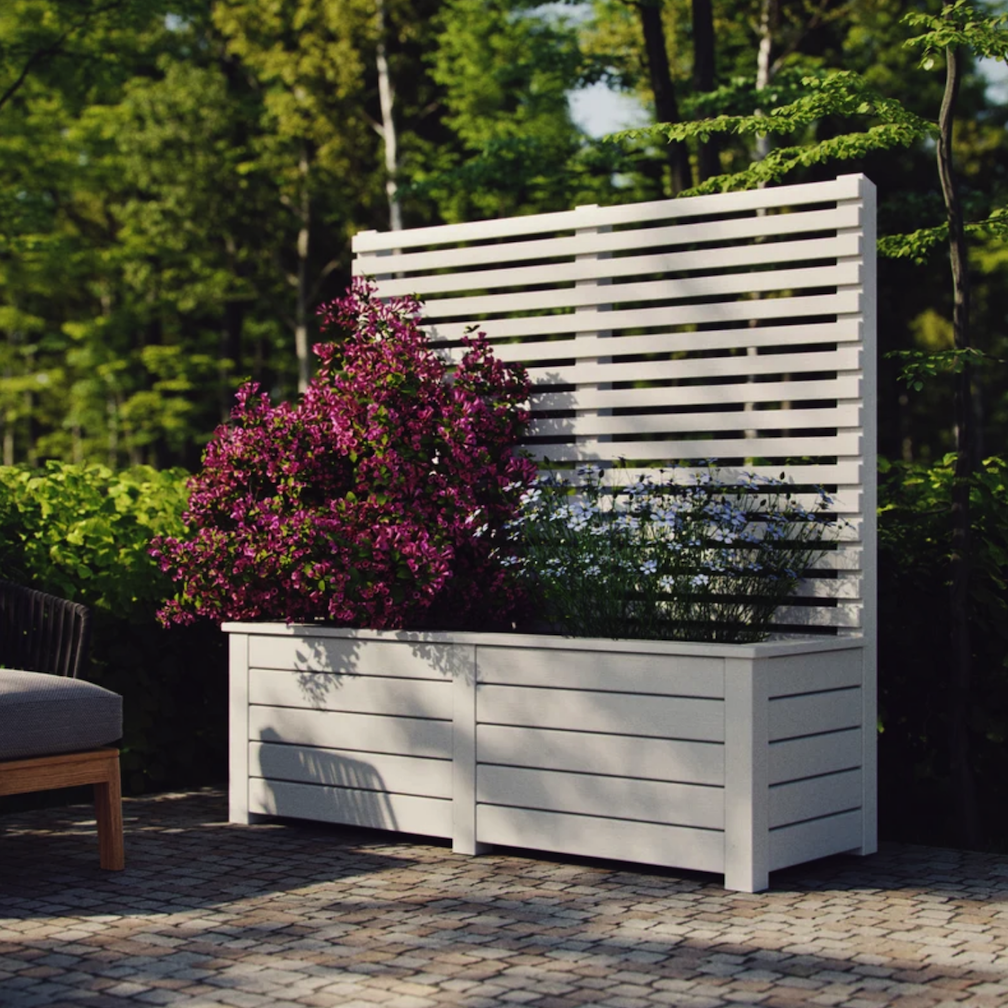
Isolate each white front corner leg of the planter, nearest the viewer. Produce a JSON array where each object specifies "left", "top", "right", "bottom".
[{"left": 725, "top": 658, "right": 770, "bottom": 892}]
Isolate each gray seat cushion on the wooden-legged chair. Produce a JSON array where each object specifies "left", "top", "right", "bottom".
[{"left": 0, "top": 668, "right": 123, "bottom": 760}]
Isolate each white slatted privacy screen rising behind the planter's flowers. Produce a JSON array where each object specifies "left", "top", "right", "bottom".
[{"left": 354, "top": 175, "right": 875, "bottom": 635}]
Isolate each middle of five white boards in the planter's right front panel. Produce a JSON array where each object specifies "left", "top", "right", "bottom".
[{"left": 476, "top": 725, "right": 725, "bottom": 786}]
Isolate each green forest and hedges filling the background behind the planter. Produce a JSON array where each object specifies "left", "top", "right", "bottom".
[{"left": 0, "top": 0, "right": 1008, "bottom": 849}]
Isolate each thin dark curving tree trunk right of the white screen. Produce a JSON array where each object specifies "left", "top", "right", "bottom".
[{"left": 937, "top": 47, "right": 980, "bottom": 849}]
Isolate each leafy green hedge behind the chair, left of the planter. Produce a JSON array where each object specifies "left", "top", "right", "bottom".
[{"left": 0, "top": 463, "right": 227, "bottom": 793}]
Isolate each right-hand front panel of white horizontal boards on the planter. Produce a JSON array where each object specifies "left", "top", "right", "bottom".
[{"left": 476, "top": 646, "right": 725, "bottom": 872}]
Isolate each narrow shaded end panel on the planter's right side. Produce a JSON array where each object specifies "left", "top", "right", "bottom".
[{"left": 768, "top": 647, "right": 862, "bottom": 870}]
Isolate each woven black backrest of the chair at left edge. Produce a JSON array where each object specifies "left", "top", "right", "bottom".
[{"left": 0, "top": 581, "right": 91, "bottom": 677}]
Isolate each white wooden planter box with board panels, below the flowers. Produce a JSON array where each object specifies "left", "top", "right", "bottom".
[{"left": 224, "top": 623, "right": 876, "bottom": 892}]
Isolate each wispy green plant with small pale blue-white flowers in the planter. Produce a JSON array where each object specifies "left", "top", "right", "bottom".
[{"left": 508, "top": 466, "right": 835, "bottom": 643}]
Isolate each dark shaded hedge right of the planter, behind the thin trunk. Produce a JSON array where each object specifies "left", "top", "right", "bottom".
[{"left": 879, "top": 456, "right": 1008, "bottom": 850}]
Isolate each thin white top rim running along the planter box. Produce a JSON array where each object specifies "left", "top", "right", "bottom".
[{"left": 221, "top": 621, "right": 865, "bottom": 658}]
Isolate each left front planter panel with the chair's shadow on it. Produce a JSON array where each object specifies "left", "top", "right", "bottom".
[{"left": 248, "top": 635, "right": 453, "bottom": 837}]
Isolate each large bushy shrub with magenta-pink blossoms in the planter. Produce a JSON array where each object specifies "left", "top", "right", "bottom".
[{"left": 151, "top": 280, "right": 535, "bottom": 629}]
